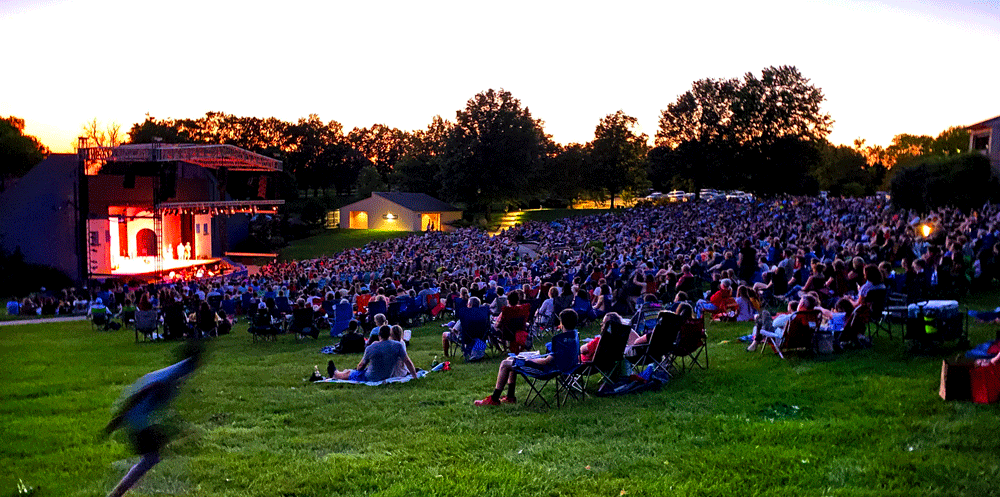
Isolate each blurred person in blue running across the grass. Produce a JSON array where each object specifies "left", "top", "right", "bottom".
[{"left": 104, "top": 341, "right": 203, "bottom": 497}]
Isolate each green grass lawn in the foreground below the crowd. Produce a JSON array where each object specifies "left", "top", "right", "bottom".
[{"left": 0, "top": 294, "right": 1000, "bottom": 497}]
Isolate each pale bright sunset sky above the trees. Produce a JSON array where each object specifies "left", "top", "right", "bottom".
[{"left": 0, "top": 0, "right": 1000, "bottom": 152}]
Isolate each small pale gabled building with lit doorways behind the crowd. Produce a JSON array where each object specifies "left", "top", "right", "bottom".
[{"left": 340, "top": 192, "right": 462, "bottom": 231}]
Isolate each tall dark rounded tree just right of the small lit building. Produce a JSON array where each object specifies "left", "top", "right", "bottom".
[{"left": 437, "top": 89, "right": 549, "bottom": 217}]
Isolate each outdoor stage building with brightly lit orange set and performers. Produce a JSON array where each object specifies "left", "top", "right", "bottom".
[{"left": 0, "top": 143, "right": 284, "bottom": 281}]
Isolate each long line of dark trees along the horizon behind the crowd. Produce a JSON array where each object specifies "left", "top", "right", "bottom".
[{"left": 0, "top": 66, "right": 984, "bottom": 209}]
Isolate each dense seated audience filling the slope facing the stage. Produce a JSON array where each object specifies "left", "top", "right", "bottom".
[{"left": 7, "top": 194, "right": 1000, "bottom": 368}]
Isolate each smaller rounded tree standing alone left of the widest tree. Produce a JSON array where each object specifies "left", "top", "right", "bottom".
[{"left": 590, "top": 110, "right": 649, "bottom": 209}]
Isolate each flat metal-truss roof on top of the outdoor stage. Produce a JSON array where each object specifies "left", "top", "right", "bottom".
[{"left": 79, "top": 143, "right": 281, "bottom": 172}]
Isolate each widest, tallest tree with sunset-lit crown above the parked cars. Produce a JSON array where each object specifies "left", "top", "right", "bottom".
[{"left": 656, "top": 66, "right": 833, "bottom": 192}]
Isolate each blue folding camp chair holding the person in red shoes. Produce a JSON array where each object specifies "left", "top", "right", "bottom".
[{"left": 512, "top": 330, "right": 580, "bottom": 407}]
